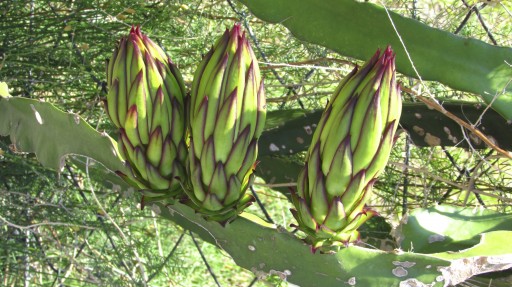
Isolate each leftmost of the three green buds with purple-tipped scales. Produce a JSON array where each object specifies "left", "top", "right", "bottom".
[{"left": 105, "top": 27, "right": 187, "bottom": 196}]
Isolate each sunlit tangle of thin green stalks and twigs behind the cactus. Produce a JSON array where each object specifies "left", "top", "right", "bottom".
[{"left": 0, "top": 0, "right": 512, "bottom": 286}]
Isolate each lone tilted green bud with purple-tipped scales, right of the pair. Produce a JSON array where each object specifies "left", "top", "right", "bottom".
[{"left": 292, "top": 47, "right": 402, "bottom": 250}]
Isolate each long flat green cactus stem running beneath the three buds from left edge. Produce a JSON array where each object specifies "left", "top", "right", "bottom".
[{"left": 0, "top": 98, "right": 512, "bottom": 286}]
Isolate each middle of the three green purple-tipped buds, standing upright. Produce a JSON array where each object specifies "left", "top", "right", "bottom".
[{"left": 187, "top": 24, "right": 265, "bottom": 222}]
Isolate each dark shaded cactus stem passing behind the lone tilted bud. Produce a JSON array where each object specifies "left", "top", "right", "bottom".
[{"left": 259, "top": 102, "right": 512, "bottom": 158}]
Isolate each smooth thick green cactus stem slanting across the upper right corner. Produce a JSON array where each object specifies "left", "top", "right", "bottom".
[{"left": 240, "top": 0, "right": 512, "bottom": 120}]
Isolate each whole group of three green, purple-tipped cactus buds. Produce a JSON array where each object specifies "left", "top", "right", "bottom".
[{"left": 105, "top": 24, "right": 401, "bottom": 243}]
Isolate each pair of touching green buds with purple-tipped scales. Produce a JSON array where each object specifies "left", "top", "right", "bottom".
[{"left": 105, "top": 24, "right": 266, "bottom": 222}]
